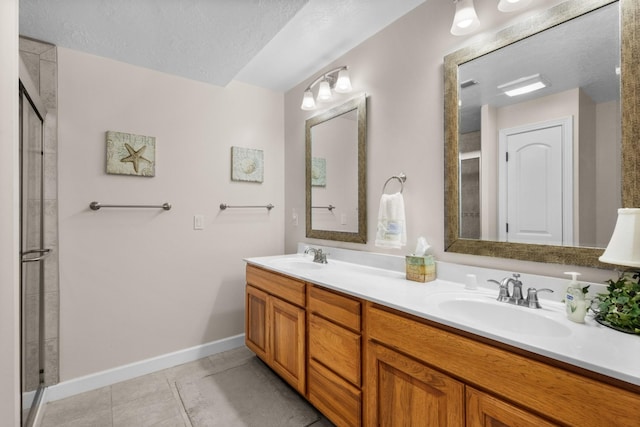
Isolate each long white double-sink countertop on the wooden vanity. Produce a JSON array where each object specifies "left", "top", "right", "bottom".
[{"left": 245, "top": 254, "right": 640, "bottom": 385}]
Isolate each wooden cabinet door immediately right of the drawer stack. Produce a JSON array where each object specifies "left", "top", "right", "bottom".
[{"left": 365, "top": 342, "right": 464, "bottom": 427}]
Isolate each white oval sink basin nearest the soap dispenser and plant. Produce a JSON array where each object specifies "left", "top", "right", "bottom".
[{"left": 438, "top": 299, "right": 571, "bottom": 338}]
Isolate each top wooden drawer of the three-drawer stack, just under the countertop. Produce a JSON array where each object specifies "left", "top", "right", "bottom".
[{"left": 308, "top": 286, "right": 362, "bottom": 332}]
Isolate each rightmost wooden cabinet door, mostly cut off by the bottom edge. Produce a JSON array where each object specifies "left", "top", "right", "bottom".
[{"left": 467, "top": 387, "right": 558, "bottom": 427}]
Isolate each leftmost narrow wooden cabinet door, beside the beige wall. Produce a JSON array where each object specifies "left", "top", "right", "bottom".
[{"left": 244, "top": 285, "right": 269, "bottom": 361}]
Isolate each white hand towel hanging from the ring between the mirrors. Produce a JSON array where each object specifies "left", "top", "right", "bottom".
[{"left": 376, "top": 193, "right": 407, "bottom": 249}]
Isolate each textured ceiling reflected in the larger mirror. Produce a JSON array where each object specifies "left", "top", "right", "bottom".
[{"left": 459, "top": 3, "right": 620, "bottom": 133}]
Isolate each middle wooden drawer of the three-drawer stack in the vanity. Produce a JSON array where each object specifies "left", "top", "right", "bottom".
[{"left": 308, "top": 314, "right": 362, "bottom": 386}]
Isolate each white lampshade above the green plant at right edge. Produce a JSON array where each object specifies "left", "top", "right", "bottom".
[{"left": 598, "top": 208, "right": 640, "bottom": 267}]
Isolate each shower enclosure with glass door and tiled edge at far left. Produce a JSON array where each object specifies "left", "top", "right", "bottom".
[{"left": 18, "top": 37, "right": 60, "bottom": 426}]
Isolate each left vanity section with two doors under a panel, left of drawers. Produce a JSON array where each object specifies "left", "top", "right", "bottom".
[{"left": 245, "top": 265, "right": 306, "bottom": 394}]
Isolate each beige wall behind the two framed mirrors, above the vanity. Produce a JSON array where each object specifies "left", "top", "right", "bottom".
[{"left": 285, "top": 0, "right": 610, "bottom": 281}]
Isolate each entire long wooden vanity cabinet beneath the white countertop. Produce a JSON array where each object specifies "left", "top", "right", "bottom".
[{"left": 245, "top": 265, "right": 640, "bottom": 427}]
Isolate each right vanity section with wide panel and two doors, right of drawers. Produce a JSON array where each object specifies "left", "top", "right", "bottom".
[{"left": 364, "top": 303, "right": 640, "bottom": 427}]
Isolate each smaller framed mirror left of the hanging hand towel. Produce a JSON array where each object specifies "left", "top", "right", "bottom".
[{"left": 305, "top": 94, "right": 367, "bottom": 243}]
